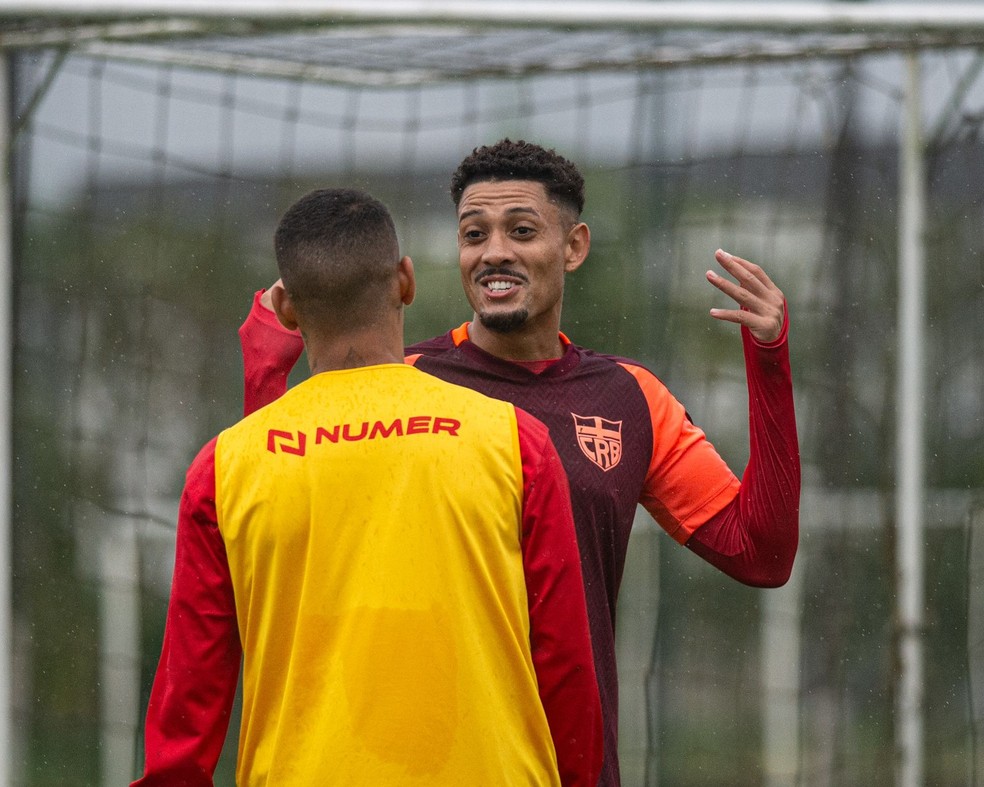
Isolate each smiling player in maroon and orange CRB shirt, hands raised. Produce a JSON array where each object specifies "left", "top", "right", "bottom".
[{"left": 240, "top": 139, "right": 800, "bottom": 785}]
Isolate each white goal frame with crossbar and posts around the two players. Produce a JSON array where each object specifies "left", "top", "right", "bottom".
[{"left": 0, "top": 6, "right": 984, "bottom": 787}]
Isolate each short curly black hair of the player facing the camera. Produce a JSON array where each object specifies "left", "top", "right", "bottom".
[{"left": 451, "top": 139, "right": 584, "bottom": 217}]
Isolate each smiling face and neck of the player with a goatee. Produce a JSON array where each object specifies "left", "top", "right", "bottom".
[{"left": 458, "top": 180, "right": 590, "bottom": 359}]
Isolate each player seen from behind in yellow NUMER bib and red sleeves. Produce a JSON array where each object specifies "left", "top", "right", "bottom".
[{"left": 135, "top": 190, "right": 602, "bottom": 787}]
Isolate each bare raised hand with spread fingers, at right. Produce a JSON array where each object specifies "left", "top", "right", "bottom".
[{"left": 706, "top": 249, "right": 785, "bottom": 343}]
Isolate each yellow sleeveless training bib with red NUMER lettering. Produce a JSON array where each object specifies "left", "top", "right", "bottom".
[{"left": 215, "top": 364, "right": 558, "bottom": 787}]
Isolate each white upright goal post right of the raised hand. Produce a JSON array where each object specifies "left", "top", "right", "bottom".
[{"left": 895, "top": 52, "right": 926, "bottom": 787}]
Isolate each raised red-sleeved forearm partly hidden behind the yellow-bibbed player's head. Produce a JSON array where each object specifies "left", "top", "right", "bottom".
[{"left": 239, "top": 282, "right": 304, "bottom": 415}]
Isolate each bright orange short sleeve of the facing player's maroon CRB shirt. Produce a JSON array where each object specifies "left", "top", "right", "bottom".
[{"left": 621, "top": 363, "right": 739, "bottom": 544}]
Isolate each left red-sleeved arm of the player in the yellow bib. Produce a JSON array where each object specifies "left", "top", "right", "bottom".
[{"left": 133, "top": 440, "right": 242, "bottom": 787}]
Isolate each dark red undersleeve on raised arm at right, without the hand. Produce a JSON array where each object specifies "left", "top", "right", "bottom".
[{"left": 687, "top": 320, "right": 800, "bottom": 587}]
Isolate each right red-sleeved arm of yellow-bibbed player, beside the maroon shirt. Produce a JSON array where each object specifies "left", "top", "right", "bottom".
[{"left": 516, "top": 409, "right": 603, "bottom": 787}]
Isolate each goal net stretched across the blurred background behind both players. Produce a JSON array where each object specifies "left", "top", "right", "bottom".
[{"left": 7, "top": 3, "right": 984, "bottom": 785}]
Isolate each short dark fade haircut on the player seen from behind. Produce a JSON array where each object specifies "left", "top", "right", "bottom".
[{"left": 274, "top": 189, "right": 400, "bottom": 328}]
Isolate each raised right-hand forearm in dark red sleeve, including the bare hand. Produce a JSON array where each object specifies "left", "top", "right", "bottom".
[{"left": 687, "top": 250, "right": 800, "bottom": 587}]
